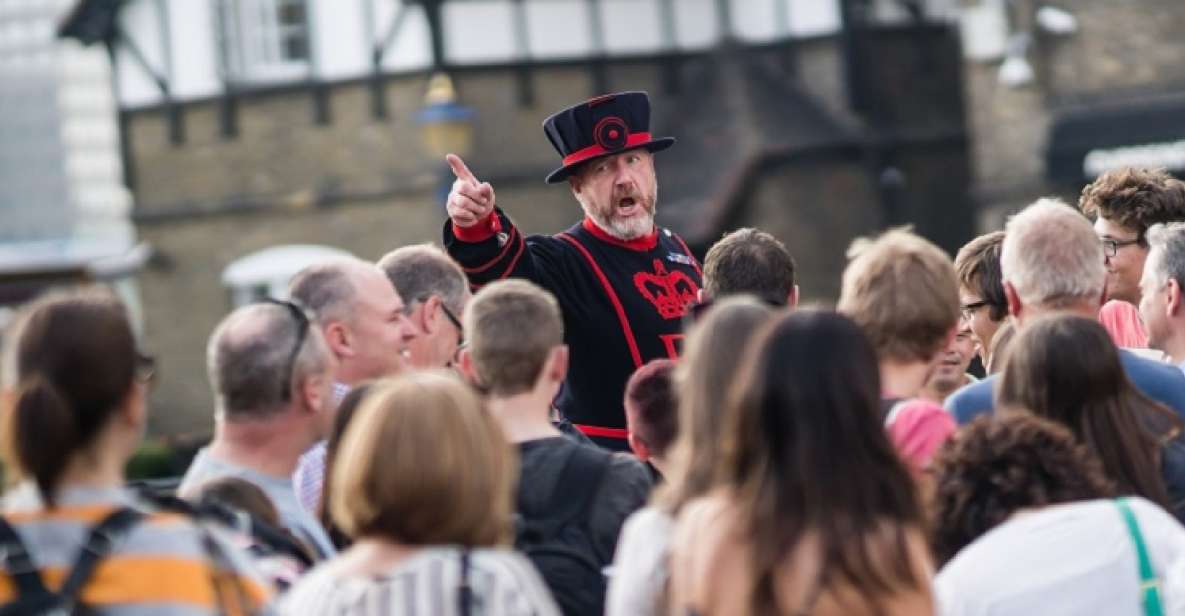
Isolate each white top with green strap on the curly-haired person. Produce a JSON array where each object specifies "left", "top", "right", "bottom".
[{"left": 934, "top": 498, "right": 1185, "bottom": 616}]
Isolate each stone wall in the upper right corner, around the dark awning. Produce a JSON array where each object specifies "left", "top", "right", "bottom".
[{"left": 965, "top": 0, "right": 1185, "bottom": 230}]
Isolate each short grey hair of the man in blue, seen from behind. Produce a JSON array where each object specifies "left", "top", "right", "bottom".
[{"left": 1000, "top": 199, "right": 1107, "bottom": 306}]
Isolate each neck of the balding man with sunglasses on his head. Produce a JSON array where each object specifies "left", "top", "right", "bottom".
[{"left": 210, "top": 411, "right": 315, "bottom": 477}]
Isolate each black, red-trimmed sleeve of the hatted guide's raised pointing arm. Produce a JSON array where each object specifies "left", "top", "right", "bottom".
[{"left": 444, "top": 207, "right": 566, "bottom": 293}]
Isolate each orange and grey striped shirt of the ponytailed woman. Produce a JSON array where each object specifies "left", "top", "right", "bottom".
[{"left": 0, "top": 483, "right": 271, "bottom": 616}]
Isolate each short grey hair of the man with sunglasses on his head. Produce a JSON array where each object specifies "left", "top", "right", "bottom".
[{"left": 206, "top": 303, "right": 329, "bottom": 421}]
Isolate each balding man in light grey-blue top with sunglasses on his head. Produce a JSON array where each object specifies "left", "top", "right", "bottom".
[{"left": 178, "top": 302, "right": 337, "bottom": 558}]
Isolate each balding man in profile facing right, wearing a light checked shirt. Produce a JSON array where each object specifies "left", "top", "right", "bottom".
[{"left": 288, "top": 257, "right": 418, "bottom": 512}]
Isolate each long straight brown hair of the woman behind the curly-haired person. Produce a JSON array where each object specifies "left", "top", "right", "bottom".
[{"left": 997, "top": 315, "right": 1185, "bottom": 519}]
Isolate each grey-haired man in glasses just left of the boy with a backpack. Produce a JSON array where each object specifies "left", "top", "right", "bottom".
[{"left": 378, "top": 244, "right": 472, "bottom": 368}]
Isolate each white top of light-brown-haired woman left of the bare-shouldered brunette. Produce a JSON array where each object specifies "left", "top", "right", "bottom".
[{"left": 604, "top": 507, "right": 674, "bottom": 616}]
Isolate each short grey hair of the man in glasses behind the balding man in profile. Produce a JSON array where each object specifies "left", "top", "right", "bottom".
[{"left": 378, "top": 244, "right": 470, "bottom": 316}]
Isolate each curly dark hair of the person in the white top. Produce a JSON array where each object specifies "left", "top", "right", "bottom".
[{"left": 930, "top": 411, "right": 1115, "bottom": 566}]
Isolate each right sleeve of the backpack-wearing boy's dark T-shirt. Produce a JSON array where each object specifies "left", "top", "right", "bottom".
[{"left": 589, "top": 454, "right": 653, "bottom": 563}]
